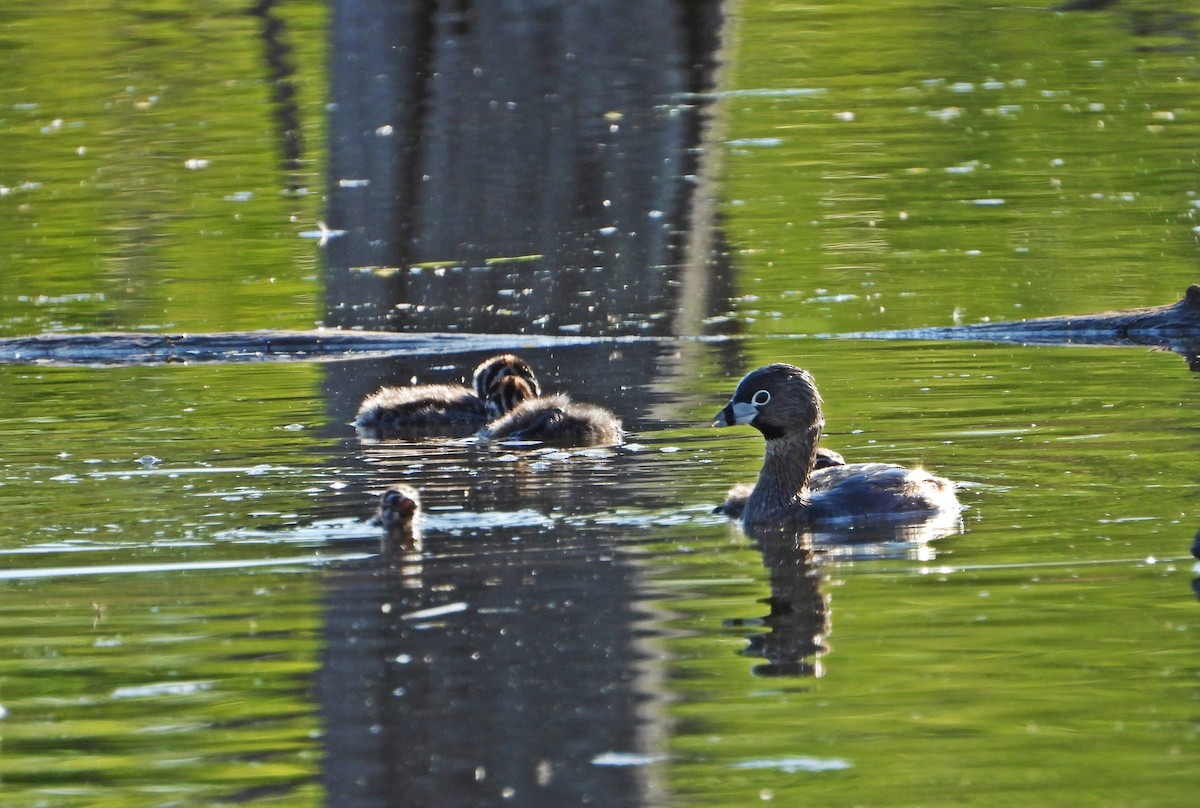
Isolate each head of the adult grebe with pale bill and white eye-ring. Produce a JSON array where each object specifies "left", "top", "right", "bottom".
[{"left": 713, "top": 363, "right": 824, "bottom": 441}]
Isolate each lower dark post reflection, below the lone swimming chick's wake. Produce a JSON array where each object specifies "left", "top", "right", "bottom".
[{"left": 317, "top": 523, "right": 661, "bottom": 808}]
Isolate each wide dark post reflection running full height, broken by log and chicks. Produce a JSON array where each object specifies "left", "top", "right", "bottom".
[{"left": 318, "top": 0, "right": 730, "bottom": 806}]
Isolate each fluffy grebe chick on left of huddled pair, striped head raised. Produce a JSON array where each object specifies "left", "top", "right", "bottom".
[{"left": 354, "top": 353, "right": 539, "bottom": 441}]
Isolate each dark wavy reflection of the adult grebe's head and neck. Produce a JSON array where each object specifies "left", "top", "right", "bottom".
[{"left": 744, "top": 528, "right": 830, "bottom": 676}]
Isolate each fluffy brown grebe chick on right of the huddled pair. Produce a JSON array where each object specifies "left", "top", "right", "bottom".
[{"left": 479, "top": 386, "right": 625, "bottom": 447}]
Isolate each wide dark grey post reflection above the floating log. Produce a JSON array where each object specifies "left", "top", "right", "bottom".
[{"left": 325, "top": 0, "right": 728, "bottom": 334}]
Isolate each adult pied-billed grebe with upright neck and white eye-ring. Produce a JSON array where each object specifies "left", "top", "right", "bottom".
[{"left": 713, "top": 363, "right": 959, "bottom": 525}]
